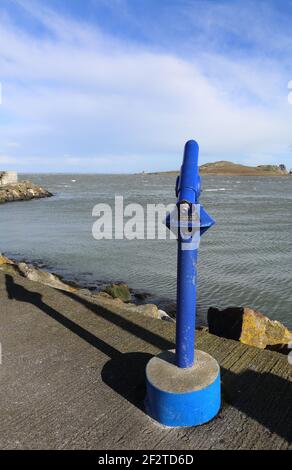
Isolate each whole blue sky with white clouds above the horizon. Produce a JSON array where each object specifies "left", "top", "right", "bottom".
[{"left": 0, "top": 0, "right": 292, "bottom": 173}]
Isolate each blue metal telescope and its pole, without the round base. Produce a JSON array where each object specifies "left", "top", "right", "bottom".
[{"left": 173, "top": 140, "right": 215, "bottom": 368}]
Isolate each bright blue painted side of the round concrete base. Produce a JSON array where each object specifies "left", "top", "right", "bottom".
[{"left": 145, "top": 372, "right": 221, "bottom": 427}]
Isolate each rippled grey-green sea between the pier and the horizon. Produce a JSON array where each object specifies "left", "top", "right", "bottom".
[{"left": 0, "top": 174, "right": 292, "bottom": 328}]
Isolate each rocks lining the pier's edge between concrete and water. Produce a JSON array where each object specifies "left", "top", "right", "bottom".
[{"left": 0, "top": 253, "right": 292, "bottom": 354}]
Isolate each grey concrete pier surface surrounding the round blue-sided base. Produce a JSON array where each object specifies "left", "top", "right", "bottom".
[{"left": 0, "top": 271, "right": 292, "bottom": 450}]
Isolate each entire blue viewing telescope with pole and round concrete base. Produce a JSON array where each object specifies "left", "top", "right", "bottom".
[{"left": 145, "top": 140, "right": 221, "bottom": 427}]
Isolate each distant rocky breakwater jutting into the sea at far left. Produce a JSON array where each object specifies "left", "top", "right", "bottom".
[{"left": 0, "top": 181, "right": 53, "bottom": 204}]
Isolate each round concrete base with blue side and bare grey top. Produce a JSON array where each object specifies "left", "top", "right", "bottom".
[{"left": 145, "top": 351, "right": 221, "bottom": 427}]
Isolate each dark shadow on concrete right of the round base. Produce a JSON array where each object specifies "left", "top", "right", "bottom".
[{"left": 221, "top": 368, "right": 292, "bottom": 444}]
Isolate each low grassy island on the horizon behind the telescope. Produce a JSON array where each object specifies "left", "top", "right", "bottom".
[{"left": 148, "top": 160, "right": 292, "bottom": 176}]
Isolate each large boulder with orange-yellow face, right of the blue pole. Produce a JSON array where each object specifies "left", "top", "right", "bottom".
[{"left": 208, "top": 307, "right": 292, "bottom": 350}]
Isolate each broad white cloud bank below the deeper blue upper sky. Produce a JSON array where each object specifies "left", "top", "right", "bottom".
[{"left": 0, "top": 0, "right": 292, "bottom": 171}]
